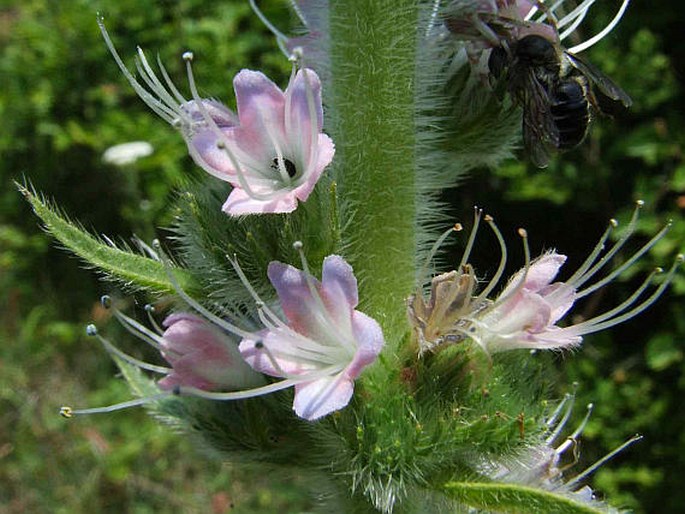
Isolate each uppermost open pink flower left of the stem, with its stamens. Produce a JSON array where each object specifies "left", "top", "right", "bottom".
[{"left": 99, "top": 20, "right": 335, "bottom": 216}]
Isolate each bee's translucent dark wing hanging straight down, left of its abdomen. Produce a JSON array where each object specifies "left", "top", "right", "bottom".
[{"left": 520, "top": 73, "right": 559, "bottom": 168}]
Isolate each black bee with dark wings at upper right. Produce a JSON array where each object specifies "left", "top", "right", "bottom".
[{"left": 488, "top": 34, "right": 632, "bottom": 168}]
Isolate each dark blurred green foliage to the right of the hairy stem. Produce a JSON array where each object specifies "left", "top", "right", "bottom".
[{"left": 448, "top": 1, "right": 685, "bottom": 513}]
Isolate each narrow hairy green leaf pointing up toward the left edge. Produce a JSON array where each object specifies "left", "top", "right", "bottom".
[{"left": 17, "top": 184, "right": 193, "bottom": 293}]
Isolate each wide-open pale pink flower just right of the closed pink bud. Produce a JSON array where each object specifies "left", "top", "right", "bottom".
[{"left": 240, "top": 255, "right": 384, "bottom": 420}]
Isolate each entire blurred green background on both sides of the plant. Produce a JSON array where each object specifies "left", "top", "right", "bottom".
[{"left": 0, "top": 0, "right": 685, "bottom": 513}]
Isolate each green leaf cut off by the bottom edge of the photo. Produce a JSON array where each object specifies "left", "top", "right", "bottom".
[{"left": 444, "top": 482, "right": 605, "bottom": 514}]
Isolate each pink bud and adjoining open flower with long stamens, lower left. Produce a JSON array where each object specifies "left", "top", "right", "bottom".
[{"left": 62, "top": 247, "right": 384, "bottom": 421}]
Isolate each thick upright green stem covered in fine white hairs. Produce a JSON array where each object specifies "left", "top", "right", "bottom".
[{"left": 328, "top": 0, "right": 418, "bottom": 346}]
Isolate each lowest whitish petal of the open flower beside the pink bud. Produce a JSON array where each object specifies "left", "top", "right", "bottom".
[{"left": 293, "top": 375, "right": 354, "bottom": 421}]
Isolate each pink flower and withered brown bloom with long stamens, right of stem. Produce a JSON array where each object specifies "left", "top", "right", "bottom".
[{"left": 408, "top": 202, "right": 683, "bottom": 354}]
